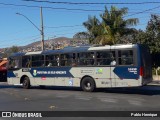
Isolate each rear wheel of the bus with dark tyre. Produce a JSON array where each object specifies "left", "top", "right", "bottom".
[{"left": 81, "top": 77, "right": 96, "bottom": 92}]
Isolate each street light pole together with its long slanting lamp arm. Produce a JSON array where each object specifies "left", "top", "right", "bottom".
[{"left": 16, "top": 7, "right": 44, "bottom": 51}]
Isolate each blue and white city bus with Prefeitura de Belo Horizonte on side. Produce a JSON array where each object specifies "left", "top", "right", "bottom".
[{"left": 7, "top": 44, "right": 152, "bottom": 92}]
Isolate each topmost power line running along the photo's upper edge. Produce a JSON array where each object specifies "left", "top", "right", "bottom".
[{"left": 22, "top": 0, "right": 160, "bottom": 5}]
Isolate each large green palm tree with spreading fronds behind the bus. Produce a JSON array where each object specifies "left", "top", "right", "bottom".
[{"left": 83, "top": 6, "right": 138, "bottom": 45}]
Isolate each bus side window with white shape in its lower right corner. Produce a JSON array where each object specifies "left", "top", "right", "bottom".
[{"left": 96, "top": 51, "right": 116, "bottom": 65}]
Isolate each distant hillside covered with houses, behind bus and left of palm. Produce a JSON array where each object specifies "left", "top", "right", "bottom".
[{"left": 0, "top": 37, "right": 88, "bottom": 56}]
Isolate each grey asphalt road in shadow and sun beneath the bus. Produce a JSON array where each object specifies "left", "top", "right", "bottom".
[{"left": 0, "top": 83, "right": 160, "bottom": 120}]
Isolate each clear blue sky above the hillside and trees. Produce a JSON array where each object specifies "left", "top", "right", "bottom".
[{"left": 0, "top": 0, "right": 160, "bottom": 48}]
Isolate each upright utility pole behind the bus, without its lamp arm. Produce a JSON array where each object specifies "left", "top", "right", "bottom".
[{"left": 40, "top": 7, "right": 44, "bottom": 51}]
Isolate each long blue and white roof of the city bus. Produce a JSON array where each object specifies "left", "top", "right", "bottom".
[{"left": 11, "top": 44, "right": 138, "bottom": 56}]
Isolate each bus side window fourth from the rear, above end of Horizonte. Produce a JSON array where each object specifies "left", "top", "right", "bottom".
[{"left": 61, "top": 53, "right": 75, "bottom": 66}]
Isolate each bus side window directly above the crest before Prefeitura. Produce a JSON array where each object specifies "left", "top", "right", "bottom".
[{"left": 32, "top": 55, "right": 44, "bottom": 67}]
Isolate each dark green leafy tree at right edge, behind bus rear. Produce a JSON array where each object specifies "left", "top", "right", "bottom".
[{"left": 144, "top": 14, "right": 160, "bottom": 68}]
